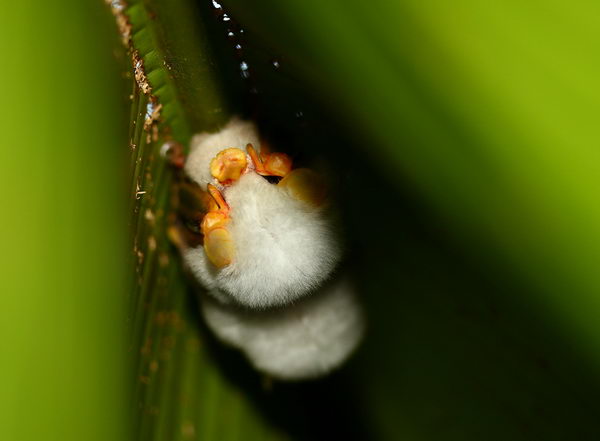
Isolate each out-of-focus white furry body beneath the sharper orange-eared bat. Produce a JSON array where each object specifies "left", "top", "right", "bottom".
[{"left": 202, "top": 278, "right": 365, "bottom": 380}]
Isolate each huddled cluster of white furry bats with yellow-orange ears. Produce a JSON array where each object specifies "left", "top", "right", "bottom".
[{"left": 183, "top": 119, "right": 364, "bottom": 379}]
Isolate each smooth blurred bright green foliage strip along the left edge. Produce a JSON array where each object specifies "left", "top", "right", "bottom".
[{"left": 0, "top": 0, "right": 131, "bottom": 441}]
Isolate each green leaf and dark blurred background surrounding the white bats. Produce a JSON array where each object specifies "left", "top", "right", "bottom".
[{"left": 0, "top": 0, "right": 600, "bottom": 441}]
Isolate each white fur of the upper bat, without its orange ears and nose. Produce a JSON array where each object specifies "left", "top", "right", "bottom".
[{"left": 184, "top": 120, "right": 340, "bottom": 308}]
